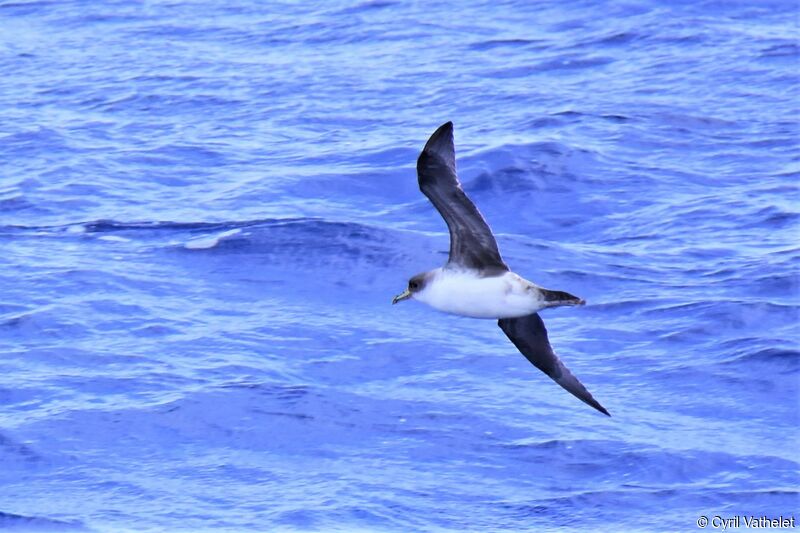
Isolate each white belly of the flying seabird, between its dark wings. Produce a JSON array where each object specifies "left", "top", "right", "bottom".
[{"left": 414, "top": 269, "right": 544, "bottom": 318}]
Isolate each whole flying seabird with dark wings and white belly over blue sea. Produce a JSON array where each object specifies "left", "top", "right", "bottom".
[{"left": 392, "top": 122, "right": 611, "bottom": 416}]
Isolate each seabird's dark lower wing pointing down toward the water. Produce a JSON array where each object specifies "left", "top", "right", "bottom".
[{"left": 497, "top": 313, "right": 611, "bottom": 416}]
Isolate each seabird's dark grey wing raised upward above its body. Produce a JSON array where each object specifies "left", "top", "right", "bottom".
[{"left": 417, "top": 122, "right": 508, "bottom": 275}]
